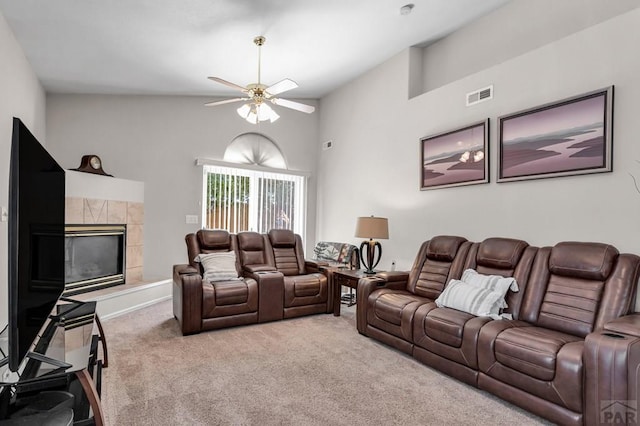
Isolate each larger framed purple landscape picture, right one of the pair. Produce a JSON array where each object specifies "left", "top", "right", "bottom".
[{"left": 497, "top": 86, "right": 613, "bottom": 182}]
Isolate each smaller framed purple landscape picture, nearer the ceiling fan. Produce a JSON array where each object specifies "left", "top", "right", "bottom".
[{"left": 420, "top": 118, "right": 489, "bottom": 191}]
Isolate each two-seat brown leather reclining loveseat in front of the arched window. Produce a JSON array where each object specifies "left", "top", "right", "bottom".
[{"left": 173, "top": 230, "right": 333, "bottom": 335}]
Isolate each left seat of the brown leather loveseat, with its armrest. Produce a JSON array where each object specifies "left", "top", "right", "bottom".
[{"left": 173, "top": 230, "right": 259, "bottom": 335}]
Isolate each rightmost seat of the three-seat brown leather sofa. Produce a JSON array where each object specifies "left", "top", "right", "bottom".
[{"left": 478, "top": 242, "right": 640, "bottom": 424}]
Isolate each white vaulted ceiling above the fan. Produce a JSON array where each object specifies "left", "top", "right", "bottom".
[{"left": 0, "top": 0, "right": 508, "bottom": 98}]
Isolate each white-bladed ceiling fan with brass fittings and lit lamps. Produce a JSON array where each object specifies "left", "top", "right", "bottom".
[{"left": 205, "top": 36, "right": 315, "bottom": 124}]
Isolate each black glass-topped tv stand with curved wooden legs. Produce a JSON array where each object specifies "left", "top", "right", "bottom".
[{"left": 0, "top": 298, "right": 107, "bottom": 426}]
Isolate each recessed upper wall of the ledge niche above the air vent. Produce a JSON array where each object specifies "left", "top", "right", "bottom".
[{"left": 421, "top": 0, "right": 640, "bottom": 92}]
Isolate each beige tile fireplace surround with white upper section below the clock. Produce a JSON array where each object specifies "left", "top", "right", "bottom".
[{"left": 65, "top": 170, "right": 144, "bottom": 284}]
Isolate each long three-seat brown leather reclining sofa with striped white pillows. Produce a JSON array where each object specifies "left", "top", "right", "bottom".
[{"left": 357, "top": 236, "right": 640, "bottom": 425}]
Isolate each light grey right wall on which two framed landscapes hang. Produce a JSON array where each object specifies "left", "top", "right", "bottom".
[{"left": 317, "top": 4, "right": 640, "bottom": 269}]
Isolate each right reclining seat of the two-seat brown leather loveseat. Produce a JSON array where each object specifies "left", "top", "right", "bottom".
[{"left": 265, "top": 229, "right": 331, "bottom": 318}]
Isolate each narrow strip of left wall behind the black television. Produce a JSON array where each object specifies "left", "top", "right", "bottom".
[{"left": 0, "top": 13, "right": 45, "bottom": 325}]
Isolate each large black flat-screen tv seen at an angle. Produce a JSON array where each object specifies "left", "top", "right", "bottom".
[{"left": 8, "top": 118, "right": 65, "bottom": 371}]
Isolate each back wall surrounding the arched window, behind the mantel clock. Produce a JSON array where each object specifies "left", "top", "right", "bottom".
[{"left": 47, "top": 94, "right": 318, "bottom": 280}]
